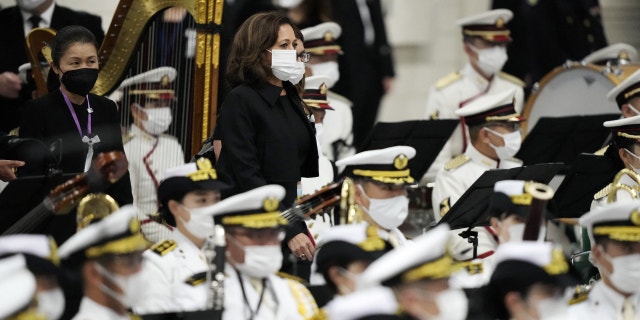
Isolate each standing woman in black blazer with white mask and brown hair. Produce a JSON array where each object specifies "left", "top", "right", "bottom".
[{"left": 217, "top": 12, "right": 318, "bottom": 278}]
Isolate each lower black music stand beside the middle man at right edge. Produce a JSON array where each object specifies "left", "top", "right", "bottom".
[{"left": 548, "top": 153, "right": 622, "bottom": 218}]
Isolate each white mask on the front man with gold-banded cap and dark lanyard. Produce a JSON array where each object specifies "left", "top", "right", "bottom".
[{"left": 228, "top": 237, "right": 282, "bottom": 279}]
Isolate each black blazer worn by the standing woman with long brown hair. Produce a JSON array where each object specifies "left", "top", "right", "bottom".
[{"left": 217, "top": 82, "right": 318, "bottom": 207}]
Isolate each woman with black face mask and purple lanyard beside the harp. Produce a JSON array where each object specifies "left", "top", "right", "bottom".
[{"left": 20, "top": 26, "right": 133, "bottom": 243}]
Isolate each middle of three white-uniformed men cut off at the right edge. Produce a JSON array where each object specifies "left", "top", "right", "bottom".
[{"left": 591, "top": 115, "right": 640, "bottom": 210}]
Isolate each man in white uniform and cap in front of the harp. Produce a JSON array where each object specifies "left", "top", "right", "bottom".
[{"left": 112, "top": 67, "right": 184, "bottom": 243}]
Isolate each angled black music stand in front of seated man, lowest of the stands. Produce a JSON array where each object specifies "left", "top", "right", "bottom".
[{"left": 438, "top": 163, "right": 563, "bottom": 230}]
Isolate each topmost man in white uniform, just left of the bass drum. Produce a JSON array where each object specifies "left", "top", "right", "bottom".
[{"left": 425, "top": 9, "right": 524, "bottom": 181}]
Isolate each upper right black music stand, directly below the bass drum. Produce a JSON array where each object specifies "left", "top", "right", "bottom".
[{"left": 516, "top": 114, "right": 620, "bottom": 165}]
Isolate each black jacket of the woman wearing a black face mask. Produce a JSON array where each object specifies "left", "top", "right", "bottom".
[{"left": 20, "top": 90, "right": 133, "bottom": 243}]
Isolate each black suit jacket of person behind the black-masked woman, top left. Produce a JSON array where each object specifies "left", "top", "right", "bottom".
[{"left": 0, "top": 4, "right": 104, "bottom": 132}]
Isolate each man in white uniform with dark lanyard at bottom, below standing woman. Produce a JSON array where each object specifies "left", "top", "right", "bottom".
[{"left": 212, "top": 185, "right": 318, "bottom": 320}]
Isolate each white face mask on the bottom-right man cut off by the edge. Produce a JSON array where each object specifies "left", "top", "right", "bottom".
[{"left": 598, "top": 246, "right": 640, "bottom": 293}]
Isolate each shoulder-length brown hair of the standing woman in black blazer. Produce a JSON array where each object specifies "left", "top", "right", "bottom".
[{"left": 226, "top": 11, "right": 300, "bottom": 88}]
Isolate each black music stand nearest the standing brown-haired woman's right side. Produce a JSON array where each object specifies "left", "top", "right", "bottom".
[{"left": 360, "top": 120, "right": 459, "bottom": 181}]
